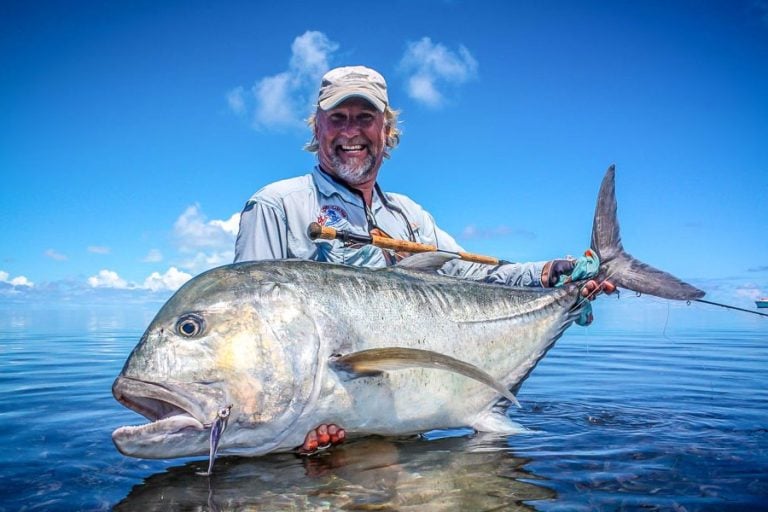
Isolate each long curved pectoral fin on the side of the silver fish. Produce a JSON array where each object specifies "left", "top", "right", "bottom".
[{"left": 330, "top": 347, "right": 520, "bottom": 407}]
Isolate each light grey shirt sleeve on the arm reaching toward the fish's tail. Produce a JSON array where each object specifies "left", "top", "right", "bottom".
[{"left": 416, "top": 212, "right": 546, "bottom": 287}]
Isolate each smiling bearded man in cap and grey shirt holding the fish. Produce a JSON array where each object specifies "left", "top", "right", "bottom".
[{"left": 235, "top": 66, "right": 609, "bottom": 453}]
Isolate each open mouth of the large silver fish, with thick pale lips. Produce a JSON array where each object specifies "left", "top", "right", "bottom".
[{"left": 112, "top": 376, "right": 220, "bottom": 458}]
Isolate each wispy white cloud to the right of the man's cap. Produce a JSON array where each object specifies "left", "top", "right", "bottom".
[{"left": 400, "top": 37, "right": 477, "bottom": 108}]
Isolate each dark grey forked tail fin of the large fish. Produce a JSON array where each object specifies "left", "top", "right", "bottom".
[{"left": 591, "top": 165, "right": 704, "bottom": 300}]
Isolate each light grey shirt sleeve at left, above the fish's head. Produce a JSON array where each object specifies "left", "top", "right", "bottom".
[{"left": 235, "top": 198, "right": 288, "bottom": 263}]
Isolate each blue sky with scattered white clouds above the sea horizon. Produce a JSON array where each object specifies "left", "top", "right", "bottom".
[{"left": 0, "top": 0, "right": 768, "bottom": 307}]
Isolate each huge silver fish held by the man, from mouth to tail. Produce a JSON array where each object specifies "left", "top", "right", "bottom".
[{"left": 112, "top": 167, "right": 704, "bottom": 458}]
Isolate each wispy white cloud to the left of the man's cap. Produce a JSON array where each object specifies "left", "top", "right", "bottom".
[{"left": 227, "top": 31, "right": 339, "bottom": 130}]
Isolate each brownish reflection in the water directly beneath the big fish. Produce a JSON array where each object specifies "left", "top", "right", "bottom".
[{"left": 115, "top": 438, "right": 555, "bottom": 511}]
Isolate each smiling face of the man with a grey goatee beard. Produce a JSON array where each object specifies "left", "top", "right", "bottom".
[{"left": 315, "top": 98, "right": 387, "bottom": 185}]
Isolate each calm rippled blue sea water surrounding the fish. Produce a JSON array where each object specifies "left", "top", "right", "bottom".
[{"left": 0, "top": 297, "right": 768, "bottom": 511}]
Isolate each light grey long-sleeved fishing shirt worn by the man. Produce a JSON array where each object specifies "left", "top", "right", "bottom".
[{"left": 235, "top": 167, "right": 546, "bottom": 286}]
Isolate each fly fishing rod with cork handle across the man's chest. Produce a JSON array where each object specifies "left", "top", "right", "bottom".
[{"left": 307, "top": 222, "right": 768, "bottom": 317}]
